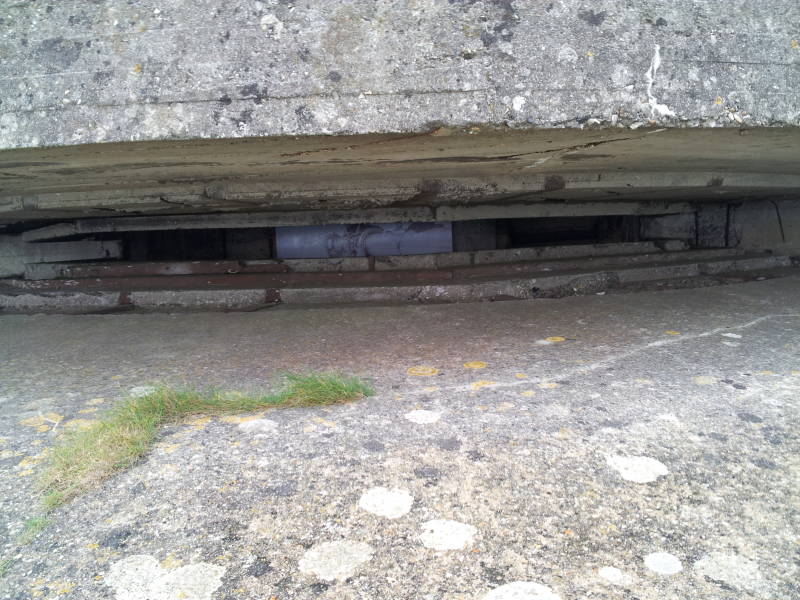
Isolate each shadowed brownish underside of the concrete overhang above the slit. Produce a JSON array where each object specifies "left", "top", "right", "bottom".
[{"left": 0, "top": 125, "right": 800, "bottom": 223}]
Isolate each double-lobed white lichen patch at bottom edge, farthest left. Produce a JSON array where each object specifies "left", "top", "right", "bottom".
[{"left": 103, "top": 554, "right": 225, "bottom": 600}]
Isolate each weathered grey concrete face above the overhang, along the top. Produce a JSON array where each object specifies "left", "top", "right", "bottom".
[{"left": 0, "top": 0, "right": 800, "bottom": 148}]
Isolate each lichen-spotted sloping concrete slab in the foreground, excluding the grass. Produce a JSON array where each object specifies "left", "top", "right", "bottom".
[{"left": 0, "top": 277, "right": 800, "bottom": 600}]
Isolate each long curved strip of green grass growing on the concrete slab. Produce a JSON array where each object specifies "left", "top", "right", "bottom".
[{"left": 39, "top": 373, "right": 373, "bottom": 511}]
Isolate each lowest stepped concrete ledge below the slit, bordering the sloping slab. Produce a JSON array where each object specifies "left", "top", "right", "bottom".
[{"left": 0, "top": 252, "right": 792, "bottom": 312}]
